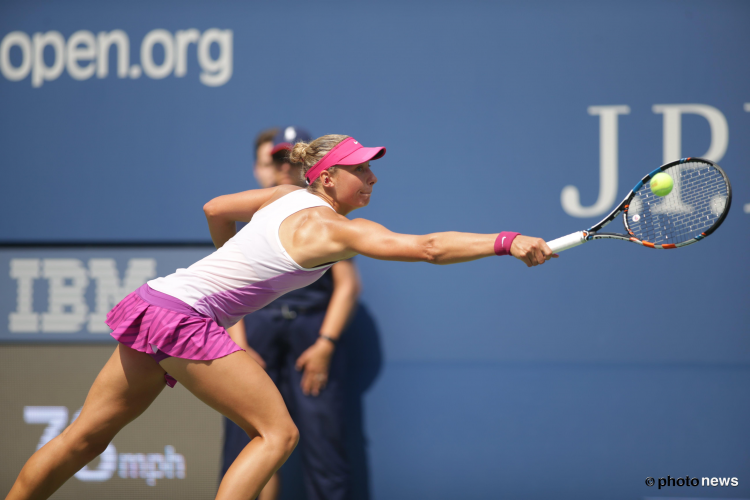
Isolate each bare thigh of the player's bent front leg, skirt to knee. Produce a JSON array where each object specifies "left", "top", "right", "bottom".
[{"left": 161, "top": 351, "right": 296, "bottom": 438}]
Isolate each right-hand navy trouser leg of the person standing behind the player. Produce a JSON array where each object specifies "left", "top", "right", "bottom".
[{"left": 287, "top": 311, "right": 351, "bottom": 500}]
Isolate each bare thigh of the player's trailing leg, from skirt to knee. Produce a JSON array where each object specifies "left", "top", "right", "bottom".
[{"left": 65, "top": 344, "right": 166, "bottom": 444}]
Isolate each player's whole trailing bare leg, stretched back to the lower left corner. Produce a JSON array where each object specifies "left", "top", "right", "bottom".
[{"left": 6, "top": 344, "right": 166, "bottom": 500}]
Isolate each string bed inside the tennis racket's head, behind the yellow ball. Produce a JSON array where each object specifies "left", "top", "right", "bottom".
[{"left": 626, "top": 162, "right": 728, "bottom": 245}]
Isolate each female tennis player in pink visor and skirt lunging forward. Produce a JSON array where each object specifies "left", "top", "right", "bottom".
[{"left": 6, "top": 135, "right": 556, "bottom": 500}]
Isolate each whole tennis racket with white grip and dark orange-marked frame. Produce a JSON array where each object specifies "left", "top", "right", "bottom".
[{"left": 547, "top": 158, "right": 732, "bottom": 252}]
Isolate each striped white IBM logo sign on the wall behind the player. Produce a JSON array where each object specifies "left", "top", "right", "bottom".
[{"left": 8, "top": 258, "right": 156, "bottom": 333}]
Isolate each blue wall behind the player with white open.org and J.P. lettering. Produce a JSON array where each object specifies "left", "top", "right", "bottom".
[{"left": 0, "top": 0, "right": 750, "bottom": 500}]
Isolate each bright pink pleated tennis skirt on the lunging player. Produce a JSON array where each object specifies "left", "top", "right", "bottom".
[{"left": 106, "top": 284, "right": 243, "bottom": 387}]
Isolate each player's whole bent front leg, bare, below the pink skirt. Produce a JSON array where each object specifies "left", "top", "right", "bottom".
[{"left": 161, "top": 351, "right": 299, "bottom": 500}]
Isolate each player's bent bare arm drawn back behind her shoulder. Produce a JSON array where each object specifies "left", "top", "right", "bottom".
[{"left": 203, "top": 186, "right": 299, "bottom": 248}]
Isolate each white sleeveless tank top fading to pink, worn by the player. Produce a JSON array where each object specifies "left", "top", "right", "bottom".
[{"left": 148, "top": 189, "right": 333, "bottom": 328}]
